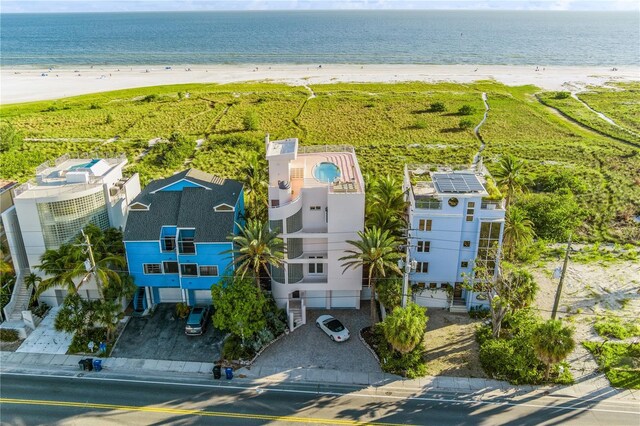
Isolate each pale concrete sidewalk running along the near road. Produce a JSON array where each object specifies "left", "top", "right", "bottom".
[{"left": 0, "top": 351, "right": 640, "bottom": 404}]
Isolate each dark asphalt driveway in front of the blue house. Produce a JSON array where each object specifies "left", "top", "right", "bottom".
[{"left": 111, "top": 303, "right": 224, "bottom": 362}]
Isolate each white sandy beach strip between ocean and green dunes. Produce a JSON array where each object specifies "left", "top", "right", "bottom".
[{"left": 0, "top": 64, "right": 640, "bottom": 104}]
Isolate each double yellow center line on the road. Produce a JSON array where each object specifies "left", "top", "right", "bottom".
[{"left": 0, "top": 398, "right": 408, "bottom": 426}]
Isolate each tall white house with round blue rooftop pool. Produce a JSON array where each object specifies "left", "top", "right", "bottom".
[{"left": 266, "top": 136, "right": 364, "bottom": 327}]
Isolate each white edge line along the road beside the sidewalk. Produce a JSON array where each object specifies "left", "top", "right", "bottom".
[{"left": 3, "top": 373, "right": 640, "bottom": 414}]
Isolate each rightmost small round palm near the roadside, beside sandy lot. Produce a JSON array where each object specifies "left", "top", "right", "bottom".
[{"left": 532, "top": 320, "right": 576, "bottom": 380}]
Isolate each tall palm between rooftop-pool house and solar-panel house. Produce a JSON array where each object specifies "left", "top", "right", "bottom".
[{"left": 339, "top": 226, "right": 402, "bottom": 326}]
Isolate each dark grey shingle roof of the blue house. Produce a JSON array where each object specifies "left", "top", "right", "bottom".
[{"left": 124, "top": 169, "right": 242, "bottom": 243}]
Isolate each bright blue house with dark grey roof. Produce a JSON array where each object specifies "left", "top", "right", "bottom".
[{"left": 124, "top": 169, "right": 244, "bottom": 311}]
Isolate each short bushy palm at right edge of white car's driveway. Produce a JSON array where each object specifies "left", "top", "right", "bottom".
[{"left": 382, "top": 303, "right": 428, "bottom": 354}]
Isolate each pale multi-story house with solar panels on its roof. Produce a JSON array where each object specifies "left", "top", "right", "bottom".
[{"left": 404, "top": 165, "right": 505, "bottom": 311}]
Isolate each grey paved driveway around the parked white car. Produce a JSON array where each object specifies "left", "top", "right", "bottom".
[{"left": 253, "top": 303, "right": 382, "bottom": 373}]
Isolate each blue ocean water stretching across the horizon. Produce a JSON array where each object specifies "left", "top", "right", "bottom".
[{"left": 0, "top": 11, "right": 640, "bottom": 67}]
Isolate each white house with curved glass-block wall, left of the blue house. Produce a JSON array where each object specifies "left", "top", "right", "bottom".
[{"left": 2, "top": 155, "right": 140, "bottom": 306}]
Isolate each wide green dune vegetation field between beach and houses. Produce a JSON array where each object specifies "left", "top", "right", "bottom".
[{"left": 0, "top": 82, "right": 640, "bottom": 242}]
